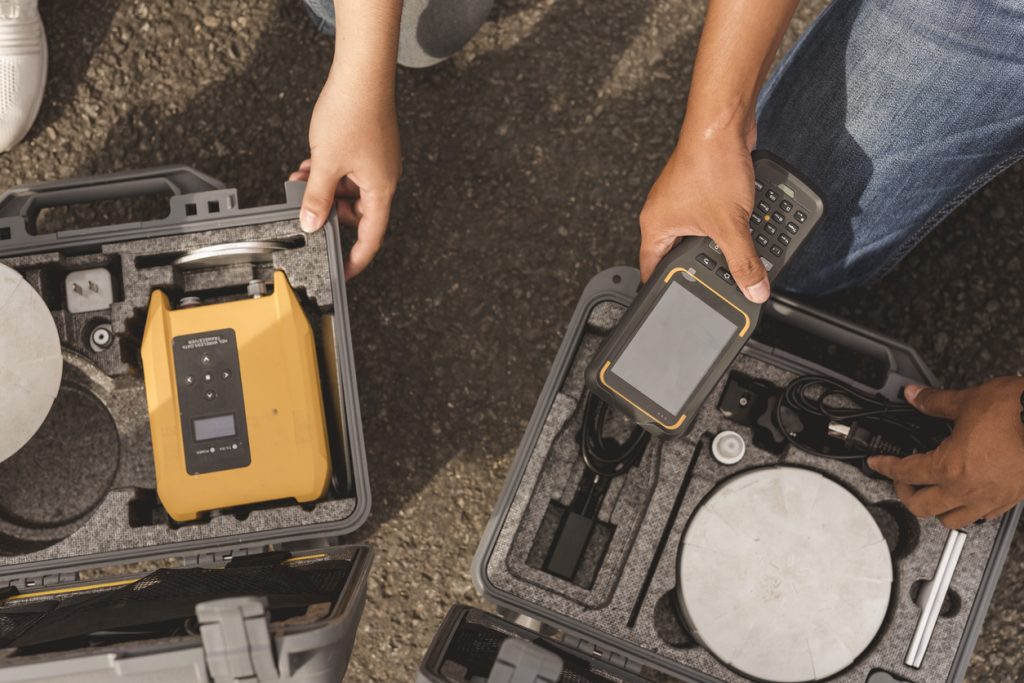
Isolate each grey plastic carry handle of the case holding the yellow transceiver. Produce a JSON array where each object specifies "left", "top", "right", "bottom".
[{"left": 0, "top": 165, "right": 224, "bottom": 245}]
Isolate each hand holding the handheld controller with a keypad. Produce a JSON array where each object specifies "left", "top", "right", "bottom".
[{"left": 640, "top": 132, "right": 771, "bottom": 303}]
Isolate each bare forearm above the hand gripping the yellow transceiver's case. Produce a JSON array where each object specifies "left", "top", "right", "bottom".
[{"left": 332, "top": 0, "right": 401, "bottom": 97}]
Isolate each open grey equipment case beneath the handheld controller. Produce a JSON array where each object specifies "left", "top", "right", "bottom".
[{"left": 417, "top": 267, "right": 1021, "bottom": 683}]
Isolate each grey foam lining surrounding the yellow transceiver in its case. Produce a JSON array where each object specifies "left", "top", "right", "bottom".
[{"left": 0, "top": 220, "right": 356, "bottom": 566}]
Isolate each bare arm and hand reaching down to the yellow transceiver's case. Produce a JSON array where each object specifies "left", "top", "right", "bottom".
[{"left": 290, "top": 0, "right": 401, "bottom": 278}]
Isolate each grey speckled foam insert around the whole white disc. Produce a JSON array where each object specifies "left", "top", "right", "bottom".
[{"left": 485, "top": 302, "right": 998, "bottom": 682}]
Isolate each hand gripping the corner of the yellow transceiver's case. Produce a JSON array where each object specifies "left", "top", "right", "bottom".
[{"left": 289, "top": 66, "right": 401, "bottom": 280}]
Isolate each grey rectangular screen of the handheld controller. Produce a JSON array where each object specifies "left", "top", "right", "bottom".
[{"left": 611, "top": 282, "right": 737, "bottom": 415}]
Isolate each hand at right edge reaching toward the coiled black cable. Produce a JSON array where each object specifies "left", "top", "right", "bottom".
[{"left": 867, "top": 377, "right": 1024, "bottom": 528}]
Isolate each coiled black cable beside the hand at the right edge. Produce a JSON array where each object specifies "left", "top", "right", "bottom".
[{"left": 774, "top": 375, "right": 952, "bottom": 460}]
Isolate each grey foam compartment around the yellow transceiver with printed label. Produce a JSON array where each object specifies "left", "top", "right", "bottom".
[{"left": 0, "top": 220, "right": 356, "bottom": 567}]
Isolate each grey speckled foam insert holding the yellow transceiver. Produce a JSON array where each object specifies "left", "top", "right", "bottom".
[{"left": 0, "top": 220, "right": 356, "bottom": 566}]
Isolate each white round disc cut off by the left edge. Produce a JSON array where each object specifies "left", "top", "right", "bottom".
[{"left": 0, "top": 264, "right": 63, "bottom": 462}]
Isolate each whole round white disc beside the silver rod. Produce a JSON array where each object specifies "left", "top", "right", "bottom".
[{"left": 679, "top": 467, "right": 893, "bottom": 682}]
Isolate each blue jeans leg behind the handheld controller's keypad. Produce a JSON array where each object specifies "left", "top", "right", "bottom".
[{"left": 758, "top": 0, "right": 1024, "bottom": 296}]
